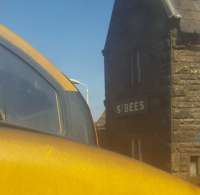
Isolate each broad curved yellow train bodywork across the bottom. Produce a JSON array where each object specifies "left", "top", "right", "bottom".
[{"left": 0, "top": 127, "right": 200, "bottom": 195}]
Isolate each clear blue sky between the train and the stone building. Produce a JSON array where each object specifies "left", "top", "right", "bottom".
[{"left": 0, "top": 0, "right": 114, "bottom": 119}]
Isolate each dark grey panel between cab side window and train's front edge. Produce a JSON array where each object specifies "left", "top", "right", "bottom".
[{"left": 66, "top": 92, "right": 96, "bottom": 144}]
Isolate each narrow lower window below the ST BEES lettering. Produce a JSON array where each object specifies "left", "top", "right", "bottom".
[{"left": 131, "top": 139, "right": 142, "bottom": 160}]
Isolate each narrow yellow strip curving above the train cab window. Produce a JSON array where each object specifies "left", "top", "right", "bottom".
[{"left": 0, "top": 25, "right": 77, "bottom": 91}]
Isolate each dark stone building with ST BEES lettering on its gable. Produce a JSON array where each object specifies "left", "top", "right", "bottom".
[{"left": 103, "top": 0, "right": 200, "bottom": 184}]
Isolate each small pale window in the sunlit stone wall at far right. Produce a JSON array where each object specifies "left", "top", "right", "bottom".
[{"left": 190, "top": 156, "right": 200, "bottom": 177}]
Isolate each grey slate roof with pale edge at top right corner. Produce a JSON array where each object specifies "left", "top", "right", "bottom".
[{"left": 162, "top": 0, "right": 200, "bottom": 34}]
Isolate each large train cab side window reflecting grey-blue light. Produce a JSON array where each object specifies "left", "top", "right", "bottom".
[{"left": 0, "top": 47, "right": 60, "bottom": 134}]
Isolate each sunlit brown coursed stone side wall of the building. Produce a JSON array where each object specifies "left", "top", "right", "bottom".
[{"left": 171, "top": 45, "right": 200, "bottom": 182}]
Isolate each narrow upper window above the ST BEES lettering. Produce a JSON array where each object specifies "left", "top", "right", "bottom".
[{"left": 130, "top": 50, "right": 142, "bottom": 86}]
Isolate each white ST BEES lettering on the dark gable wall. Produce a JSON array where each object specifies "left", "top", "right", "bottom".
[{"left": 113, "top": 98, "right": 147, "bottom": 116}]
